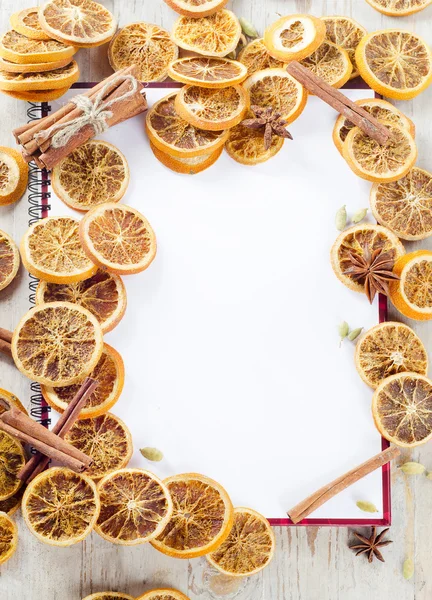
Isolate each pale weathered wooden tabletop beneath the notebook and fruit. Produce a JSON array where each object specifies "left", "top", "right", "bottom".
[{"left": 0, "top": 0, "right": 432, "bottom": 600}]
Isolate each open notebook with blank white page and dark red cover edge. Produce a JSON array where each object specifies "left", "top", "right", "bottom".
[{"left": 27, "top": 84, "right": 390, "bottom": 525}]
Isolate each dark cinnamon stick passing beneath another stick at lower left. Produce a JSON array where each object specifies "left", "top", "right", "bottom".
[{"left": 17, "top": 377, "right": 98, "bottom": 483}]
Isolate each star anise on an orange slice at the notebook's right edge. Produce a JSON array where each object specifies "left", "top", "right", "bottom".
[{"left": 344, "top": 246, "right": 400, "bottom": 304}]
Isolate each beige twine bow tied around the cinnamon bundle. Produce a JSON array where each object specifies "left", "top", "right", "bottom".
[{"left": 35, "top": 75, "right": 138, "bottom": 148}]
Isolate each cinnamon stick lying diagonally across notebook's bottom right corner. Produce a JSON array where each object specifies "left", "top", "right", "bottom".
[{"left": 288, "top": 446, "right": 400, "bottom": 524}]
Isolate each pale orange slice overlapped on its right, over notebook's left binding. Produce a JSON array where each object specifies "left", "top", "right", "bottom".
[{"left": 20, "top": 217, "right": 97, "bottom": 283}]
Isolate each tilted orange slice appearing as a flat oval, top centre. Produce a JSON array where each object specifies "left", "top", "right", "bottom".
[{"left": 168, "top": 56, "right": 248, "bottom": 89}]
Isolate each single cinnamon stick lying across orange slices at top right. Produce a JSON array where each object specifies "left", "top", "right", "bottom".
[{"left": 286, "top": 61, "right": 390, "bottom": 145}]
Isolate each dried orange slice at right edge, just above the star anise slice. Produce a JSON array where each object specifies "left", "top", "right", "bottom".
[{"left": 370, "top": 167, "right": 432, "bottom": 240}]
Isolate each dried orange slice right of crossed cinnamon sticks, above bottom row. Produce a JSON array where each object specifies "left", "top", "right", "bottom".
[{"left": 65, "top": 413, "right": 133, "bottom": 480}]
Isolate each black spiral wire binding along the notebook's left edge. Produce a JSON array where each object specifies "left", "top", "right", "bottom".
[{"left": 27, "top": 102, "right": 51, "bottom": 432}]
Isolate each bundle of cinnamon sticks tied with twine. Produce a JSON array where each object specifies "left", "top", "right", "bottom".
[{"left": 13, "top": 65, "right": 147, "bottom": 170}]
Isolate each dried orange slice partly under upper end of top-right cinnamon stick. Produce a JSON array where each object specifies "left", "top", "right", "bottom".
[{"left": 301, "top": 41, "right": 353, "bottom": 88}]
